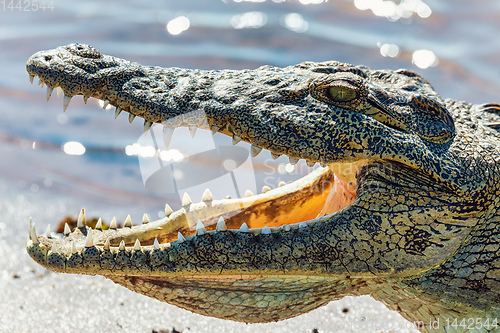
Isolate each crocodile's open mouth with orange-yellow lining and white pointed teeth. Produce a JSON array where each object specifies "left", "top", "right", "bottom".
[{"left": 25, "top": 73, "right": 368, "bottom": 253}]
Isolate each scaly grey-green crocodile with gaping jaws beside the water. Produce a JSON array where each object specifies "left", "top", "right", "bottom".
[{"left": 26, "top": 43, "right": 500, "bottom": 332}]
